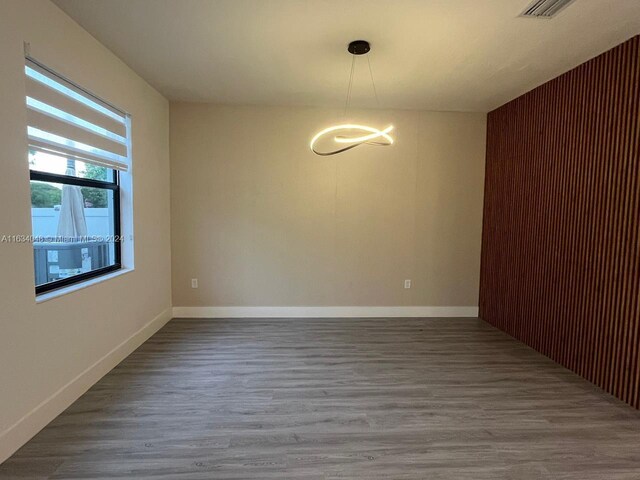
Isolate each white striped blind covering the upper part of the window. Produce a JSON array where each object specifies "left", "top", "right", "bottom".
[{"left": 25, "top": 59, "right": 129, "bottom": 171}]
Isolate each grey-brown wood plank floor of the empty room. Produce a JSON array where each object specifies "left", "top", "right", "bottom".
[{"left": 0, "top": 319, "right": 640, "bottom": 480}]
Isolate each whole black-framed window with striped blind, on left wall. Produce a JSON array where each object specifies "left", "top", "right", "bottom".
[{"left": 25, "top": 58, "right": 130, "bottom": 294}]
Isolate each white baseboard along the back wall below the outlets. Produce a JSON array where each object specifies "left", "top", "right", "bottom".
[{"left": 173, "top": 307, "right": 478, "bottom": 318}]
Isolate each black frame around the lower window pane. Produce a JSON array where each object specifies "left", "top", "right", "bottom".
[{"left": 29, "top": 170, "right": 122, "bottom": 296}]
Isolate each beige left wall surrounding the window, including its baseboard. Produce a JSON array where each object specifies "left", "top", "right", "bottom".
[{"left": 0, "top": 0, "right": 171, "bottom": 461}]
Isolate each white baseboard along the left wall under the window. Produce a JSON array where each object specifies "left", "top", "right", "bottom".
[{"left": 0, "top": 308, "right": 171, "bottom": 463}]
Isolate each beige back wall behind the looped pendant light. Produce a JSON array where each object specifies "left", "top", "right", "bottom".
[{"left": 170, "top": 103, "right": 486, "bottom": 306}]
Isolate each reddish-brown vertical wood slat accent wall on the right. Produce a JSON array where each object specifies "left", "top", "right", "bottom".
[{"left": 480, "top": 37, "right": 640, "bottom": 408}]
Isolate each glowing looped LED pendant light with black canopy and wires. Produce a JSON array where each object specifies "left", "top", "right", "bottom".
[{"left": 309, "top": 40, "right": 393, "bottom": 156}]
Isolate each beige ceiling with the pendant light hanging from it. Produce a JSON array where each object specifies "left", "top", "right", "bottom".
[{"left": 54, "top": 0, "right": 640, "bottom": 111}]
